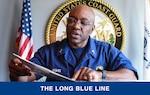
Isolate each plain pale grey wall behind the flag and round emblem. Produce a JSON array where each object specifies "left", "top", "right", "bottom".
[{"left": 0, "top": 0, "right": 144, "bottom": 82}]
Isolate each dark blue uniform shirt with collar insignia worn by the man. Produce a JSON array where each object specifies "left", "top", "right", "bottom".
[{"left": 31, "top": 38, "right": 137, "bottom": 79}]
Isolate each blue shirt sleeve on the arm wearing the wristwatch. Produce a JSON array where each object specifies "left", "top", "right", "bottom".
[{"left": 108, "top": 45, "right": 138, "bottom": 78}]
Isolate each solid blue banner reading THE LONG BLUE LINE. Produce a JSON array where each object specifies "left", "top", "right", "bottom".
[{"left": 0, "top": 82, "right": 150, "bottom": 95}]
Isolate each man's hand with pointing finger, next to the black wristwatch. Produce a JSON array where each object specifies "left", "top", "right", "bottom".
[{"left": 72, "top": 67, "right": 102, "bottom": 82}]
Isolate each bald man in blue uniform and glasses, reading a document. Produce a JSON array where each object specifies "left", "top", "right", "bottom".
[{"left": 9, "top": 5, "right": 138, "bottom": 81}]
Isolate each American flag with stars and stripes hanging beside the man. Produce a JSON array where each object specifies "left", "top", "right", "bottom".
[{"left": 16, "top": 0, "right": 33, "bottom": 60}]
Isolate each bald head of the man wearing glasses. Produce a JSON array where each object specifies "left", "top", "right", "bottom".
[{"left": 66, "top": 5, "right": 95, "bottom": 48}]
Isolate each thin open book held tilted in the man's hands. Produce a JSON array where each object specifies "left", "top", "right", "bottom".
[{"left": 13, "top": 53, "right": 73, "bottom": 81}]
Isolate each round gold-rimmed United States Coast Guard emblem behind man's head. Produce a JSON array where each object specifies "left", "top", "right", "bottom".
[{"left": 46, "top": 0, "right": 125, "bottom": 50}]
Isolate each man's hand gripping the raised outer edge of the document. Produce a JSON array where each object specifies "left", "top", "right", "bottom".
[{"left": 9, "top": 58, "right": 31, "bottom": 81}]
